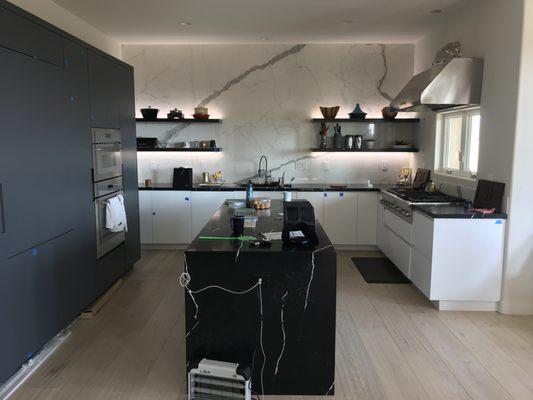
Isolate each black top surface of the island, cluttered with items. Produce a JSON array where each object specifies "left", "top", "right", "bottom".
[{"left": 185, "top": 200, "right": 335, "bottom": 253}]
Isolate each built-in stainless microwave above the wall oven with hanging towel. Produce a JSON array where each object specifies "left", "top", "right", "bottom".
[{"left": 92, "top": 128, "right": 122, "bottom": 182}]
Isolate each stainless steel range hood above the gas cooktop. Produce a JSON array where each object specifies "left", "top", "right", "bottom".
[{"left": 391, "top": 57, "right": 483, "bottom": 111}]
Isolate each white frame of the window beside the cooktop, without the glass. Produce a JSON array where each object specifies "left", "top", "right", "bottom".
[{"left": 435, "top": 107, "right": 481, "bottom": 180}]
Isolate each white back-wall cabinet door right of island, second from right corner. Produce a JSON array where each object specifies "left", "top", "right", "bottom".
[{"left": 323, "top": 192, "right": 357, "bottom": 245}]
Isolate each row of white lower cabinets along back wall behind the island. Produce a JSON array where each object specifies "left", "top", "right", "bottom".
[{"left": 139, "top": 190, "right": 379, "bottom": 246}]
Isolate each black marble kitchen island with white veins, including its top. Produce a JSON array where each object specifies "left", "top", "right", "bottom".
[{"left": 182, "top": 200, "right": 337, "bottom": 395}]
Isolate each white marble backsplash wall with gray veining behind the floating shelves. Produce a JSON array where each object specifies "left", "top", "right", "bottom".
[{"left": 123, "top": 44, "right": 416, "bottom": 183}]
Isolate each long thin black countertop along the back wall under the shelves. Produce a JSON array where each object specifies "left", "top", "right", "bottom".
[{"left": 139, "top": 183, "right": 384, "bottom": 192}]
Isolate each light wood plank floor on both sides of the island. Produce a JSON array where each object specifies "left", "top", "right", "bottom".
[{"left": 9, "top": 251, "right": 533, "bottom": 400}]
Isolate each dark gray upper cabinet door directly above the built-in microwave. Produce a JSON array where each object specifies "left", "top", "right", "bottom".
[{"left": 89, "top": 51, "right": 120, "bottom": 129}]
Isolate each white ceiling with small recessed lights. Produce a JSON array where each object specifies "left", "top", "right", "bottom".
[{"left": 54, "top": 0, "right": 469, "bottom": 44}]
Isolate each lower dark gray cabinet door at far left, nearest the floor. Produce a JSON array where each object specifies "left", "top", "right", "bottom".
[{"left": 0, "top": 232, "right": 76, "bottom": 382}]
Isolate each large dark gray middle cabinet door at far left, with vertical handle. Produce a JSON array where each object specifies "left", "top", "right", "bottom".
[{"left": 0, "top": 47, "right": 72, "bottom": 256}]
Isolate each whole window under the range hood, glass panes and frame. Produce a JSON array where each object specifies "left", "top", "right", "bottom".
[{"left": 435, "top": 108, "right": 481, "bottom": 178}]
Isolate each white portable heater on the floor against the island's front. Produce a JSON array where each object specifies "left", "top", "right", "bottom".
[{"left": 188, "top": 358, "right": 252, "bottom": 400}]
